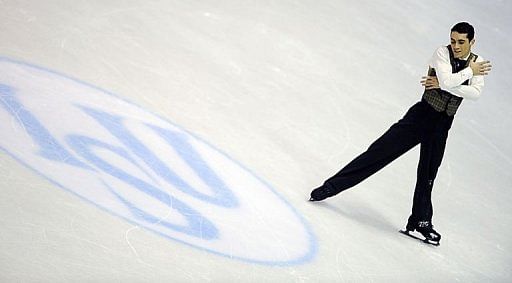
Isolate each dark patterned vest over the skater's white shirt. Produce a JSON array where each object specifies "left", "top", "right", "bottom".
[{"left": 422, "top": 45, "right": 478, "bottom": 116}]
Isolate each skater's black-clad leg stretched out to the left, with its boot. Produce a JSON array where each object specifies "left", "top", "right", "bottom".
[{"left": 310, "top": 102, "right": 425, "bottom": 201}]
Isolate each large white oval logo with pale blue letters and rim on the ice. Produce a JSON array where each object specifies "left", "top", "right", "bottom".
[{"left": 0, "top": 58, "right": 316, "bottom": 265}]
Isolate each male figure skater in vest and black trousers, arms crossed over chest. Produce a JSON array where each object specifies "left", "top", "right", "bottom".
[{"left": 310, "top": 22, "right": 491, "bottom": 245}]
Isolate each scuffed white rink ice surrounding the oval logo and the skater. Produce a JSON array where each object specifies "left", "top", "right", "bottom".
[{"left": 0, "top": 0, "right": 512, "bottom": 282}]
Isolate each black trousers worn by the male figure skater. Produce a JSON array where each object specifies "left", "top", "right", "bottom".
[{"left": 324, "top": 101, "right": 453, "bottom": 223}]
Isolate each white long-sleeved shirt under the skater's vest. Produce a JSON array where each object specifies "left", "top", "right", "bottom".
[{"left": 430, "top": 46, "right": 484, "bottom": 100}]
